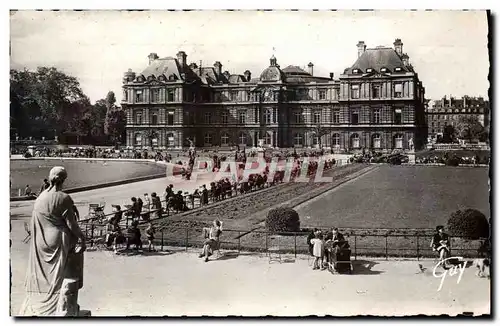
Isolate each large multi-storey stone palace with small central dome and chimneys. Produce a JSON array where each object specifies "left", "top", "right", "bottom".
[{"left": 121, "top": 39, "right": 427, "bottom": 152}]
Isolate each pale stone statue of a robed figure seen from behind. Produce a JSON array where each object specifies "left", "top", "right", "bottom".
[{"left": 20, "top": 166, "right": 85, "bottom": 316}]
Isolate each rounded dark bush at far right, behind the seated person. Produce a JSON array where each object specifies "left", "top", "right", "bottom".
[{"left": 448, "top": 208, "right": 490, "bottom": 240}]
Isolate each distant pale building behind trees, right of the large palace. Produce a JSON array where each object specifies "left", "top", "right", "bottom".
[{"left": 426, "top": 96, "right": 490, "bottom": 139}]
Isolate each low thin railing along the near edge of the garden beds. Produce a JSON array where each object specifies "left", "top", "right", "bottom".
[{"left": 79, "top": 221, "right": 485, "bottom": 260}]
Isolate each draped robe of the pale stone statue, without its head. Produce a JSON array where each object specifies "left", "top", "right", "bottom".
[{"left": 20, "top": 187, "right": 76, "bottom": 316}]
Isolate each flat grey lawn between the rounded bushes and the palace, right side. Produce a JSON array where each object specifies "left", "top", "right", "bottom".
[{"left": 297, "top": 165, "right": 490, "bottom": 228}]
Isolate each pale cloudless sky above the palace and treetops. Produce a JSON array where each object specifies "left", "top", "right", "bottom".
[{"left": 10, "top": 10, "right": 489, "bottom": 102}]
